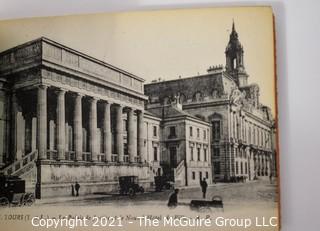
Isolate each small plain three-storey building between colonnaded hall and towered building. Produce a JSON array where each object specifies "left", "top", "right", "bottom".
[{"left": 146, "top": 100, "right": 212, "bottom": 186}]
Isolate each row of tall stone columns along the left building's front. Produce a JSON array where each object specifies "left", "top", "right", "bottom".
[{"left": 37, "top": 85, "right": 146, "bottom": 163}]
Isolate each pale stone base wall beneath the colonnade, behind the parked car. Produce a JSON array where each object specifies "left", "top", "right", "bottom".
[{"left": 37, "top": 162, "right": 153, "bottom": 198}]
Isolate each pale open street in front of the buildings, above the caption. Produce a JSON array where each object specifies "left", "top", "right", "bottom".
[{"left": 2, "top": 180, "right": 278, "bottom": 231}]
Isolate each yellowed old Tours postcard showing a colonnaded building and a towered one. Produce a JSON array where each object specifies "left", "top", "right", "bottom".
[{"left": 0, "top": 7, "right": 280, "bottom": 230}]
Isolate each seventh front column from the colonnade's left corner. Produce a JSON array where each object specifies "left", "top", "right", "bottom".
[{"left": 127, "top": 108, "right": 137, "bottom": 163}]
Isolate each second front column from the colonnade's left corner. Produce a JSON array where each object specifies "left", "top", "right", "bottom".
[{"left": 57, "top": 89, "right": 66, "bottom": 160}]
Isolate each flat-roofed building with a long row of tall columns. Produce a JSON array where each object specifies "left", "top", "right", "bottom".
[{"left": 0, "top": 38, "right": 161, "bottom": 198}]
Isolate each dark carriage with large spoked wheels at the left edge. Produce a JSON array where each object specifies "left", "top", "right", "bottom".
[{"left": 0, "top": 176, "right": 35, "bottom": 207}]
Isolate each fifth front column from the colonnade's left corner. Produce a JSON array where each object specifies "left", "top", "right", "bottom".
[{"left": 103, "top": 102, "right": 112, "bottom": 162}]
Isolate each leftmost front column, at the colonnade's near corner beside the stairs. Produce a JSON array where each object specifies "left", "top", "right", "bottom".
[{"left": 37, "top": 85, "right": 47, "bottom": 159}]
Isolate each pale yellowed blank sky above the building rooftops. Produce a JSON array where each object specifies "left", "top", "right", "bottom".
[{"left": 0, "top": 7, "right": 275, "bottom": 111}]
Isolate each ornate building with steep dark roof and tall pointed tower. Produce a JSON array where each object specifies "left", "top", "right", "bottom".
[{"left": 145, "top": 24, "right": 275, "bottom": 181}]
